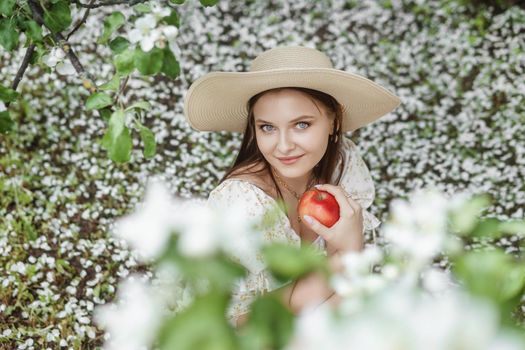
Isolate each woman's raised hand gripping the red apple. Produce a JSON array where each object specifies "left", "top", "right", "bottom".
[{"left": 303, "top": 184, "right": 364, "bottom": 253}]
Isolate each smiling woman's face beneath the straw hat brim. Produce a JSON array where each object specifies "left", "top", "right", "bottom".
[{"left": 253, "top": 89, "right": 333, "bottom": 180}]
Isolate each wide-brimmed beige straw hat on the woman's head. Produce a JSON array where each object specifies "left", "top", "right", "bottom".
[{"left": 184, "top": 46, "right": 401, "bottom": 132}]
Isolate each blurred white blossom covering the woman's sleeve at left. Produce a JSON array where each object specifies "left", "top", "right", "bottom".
[{"left": 114, "top": 181, "right": 260, "bottom": 262}]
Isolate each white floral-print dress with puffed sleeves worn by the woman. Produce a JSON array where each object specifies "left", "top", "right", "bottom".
[{"left": 207, "top": 138, "right": 381, "bottom": 325}]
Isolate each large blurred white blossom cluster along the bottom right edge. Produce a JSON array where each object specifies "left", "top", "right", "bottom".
[{"left": 286, "top": 285, "right": 525, "bottom": 350}]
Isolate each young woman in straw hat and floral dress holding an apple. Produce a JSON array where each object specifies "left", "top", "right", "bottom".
[{"left": 184, "top": 46, "right": 400, "bottom": 326}]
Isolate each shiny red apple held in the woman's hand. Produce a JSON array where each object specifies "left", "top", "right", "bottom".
[{"left": 297, "top": 189, "right": 339, "bottom": 227}]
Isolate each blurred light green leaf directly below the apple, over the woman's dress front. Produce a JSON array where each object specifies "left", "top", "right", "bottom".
[{"left": 262, "top": 243, "right": 328, "bottom": 282}]
